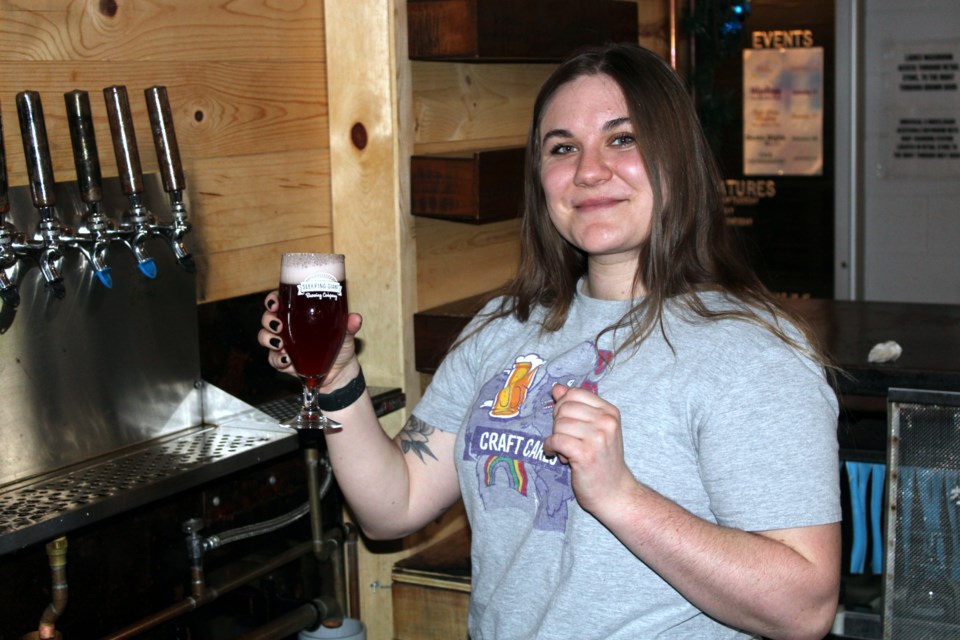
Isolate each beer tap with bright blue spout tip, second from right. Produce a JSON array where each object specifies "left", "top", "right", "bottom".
[{"left": 103, "top": 85, "right": 157, "bottom": 278}]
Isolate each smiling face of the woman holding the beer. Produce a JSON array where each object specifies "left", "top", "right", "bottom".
[{"left": 540, "top": 74, "right": 653, "bottom": 267}]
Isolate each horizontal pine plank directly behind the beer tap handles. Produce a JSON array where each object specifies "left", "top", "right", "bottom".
[{"left": 0, "top": 62, "right": 329, "bottom": 185}]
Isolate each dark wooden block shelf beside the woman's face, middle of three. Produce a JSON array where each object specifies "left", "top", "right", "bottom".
[{"left": 410, "top": 149, "right": 523, "bottom": 224}]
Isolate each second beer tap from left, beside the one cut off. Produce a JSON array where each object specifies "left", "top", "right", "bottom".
[{"left": 16, "top": 91, "right": 69, "bottom": 298}]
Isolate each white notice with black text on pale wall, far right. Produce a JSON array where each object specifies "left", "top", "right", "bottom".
[{"left": 877, "top": 41, "right": 960, "bottom": 178}]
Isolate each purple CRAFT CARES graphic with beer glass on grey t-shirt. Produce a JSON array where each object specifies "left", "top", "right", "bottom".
[{"left": 463, "top": 342, "right": 610, "bottom": 532}]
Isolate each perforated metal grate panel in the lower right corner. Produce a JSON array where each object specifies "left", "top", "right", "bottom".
[{"left": 884, "top": 390, "right": 960, "bottom": 640}]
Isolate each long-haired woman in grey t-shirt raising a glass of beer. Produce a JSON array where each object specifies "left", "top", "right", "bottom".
[{"left": 260, "top": 45, "right": 840, "bottom": 640}]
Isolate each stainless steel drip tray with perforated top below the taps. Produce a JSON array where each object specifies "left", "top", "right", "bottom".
[{"left": 0, "top": 396, "right": 299, "bottom": 555}]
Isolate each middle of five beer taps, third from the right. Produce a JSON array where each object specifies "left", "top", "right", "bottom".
[{"left": 63, "top": 90, "right": 114, "bottom": 289}]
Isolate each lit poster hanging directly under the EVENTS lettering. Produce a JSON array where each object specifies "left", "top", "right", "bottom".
[{"left": 743, "top": 47, "right": 823, "bottom": 176}]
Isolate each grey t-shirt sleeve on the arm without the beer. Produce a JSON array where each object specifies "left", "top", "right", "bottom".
[{"left": 698, "top": 326, "right": 840, "bottom": 531}]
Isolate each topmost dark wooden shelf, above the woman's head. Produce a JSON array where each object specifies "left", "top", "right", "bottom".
[{"left": 407, "top": 0, "right": 638, "bottom": 62}]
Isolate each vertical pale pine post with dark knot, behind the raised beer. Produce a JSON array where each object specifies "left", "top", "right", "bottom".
[{"left": 325, "top": 0, "right": 418, "bottom": 640}]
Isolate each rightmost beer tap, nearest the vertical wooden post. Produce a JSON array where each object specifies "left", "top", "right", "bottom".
[{"left": 144, "top": 86, "right": 196, "bottom": 273}]
